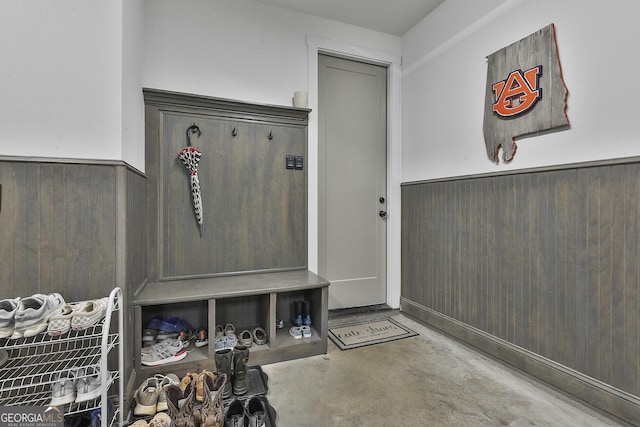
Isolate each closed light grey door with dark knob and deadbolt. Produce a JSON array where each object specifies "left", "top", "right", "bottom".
[{"left": 318, "top": 55, "right": 387, "bottom": 309}]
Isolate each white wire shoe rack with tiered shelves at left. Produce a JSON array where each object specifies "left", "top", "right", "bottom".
[{"left": 0, "top": 288, "right": 124, "bottom": 427}]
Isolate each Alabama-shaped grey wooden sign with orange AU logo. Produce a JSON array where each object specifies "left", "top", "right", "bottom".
[{"left": 483, "top": 24, "right": 569, "bottom": 163}]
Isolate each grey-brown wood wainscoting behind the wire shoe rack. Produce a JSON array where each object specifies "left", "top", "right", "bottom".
[{"left": 0, "top": 157, "right": 147, "bottom": 384}]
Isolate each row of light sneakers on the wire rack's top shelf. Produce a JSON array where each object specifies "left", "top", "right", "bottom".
[{"left": 0, "top": 293, "right": 109, "bottom": 339}]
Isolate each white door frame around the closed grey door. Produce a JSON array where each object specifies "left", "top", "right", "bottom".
[{"left": 306, "top": 36, "right": 402, "bottom": 308}]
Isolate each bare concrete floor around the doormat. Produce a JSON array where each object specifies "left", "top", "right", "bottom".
[{"left": 262, "top": 311, "right": 625, "bottom": 427}]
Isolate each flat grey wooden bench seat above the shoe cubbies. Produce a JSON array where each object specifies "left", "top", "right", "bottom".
[{"left": 133, "top": 270, "right": 329, "bottom": 306}]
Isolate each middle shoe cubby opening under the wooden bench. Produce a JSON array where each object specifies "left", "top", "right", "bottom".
[{"left": 215, "top": 294, "right": 270, "bottom": 352}]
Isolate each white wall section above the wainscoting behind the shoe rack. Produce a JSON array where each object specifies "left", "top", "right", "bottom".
[{"left": 0, "top": 0, "right": 122, "bottom": 163}]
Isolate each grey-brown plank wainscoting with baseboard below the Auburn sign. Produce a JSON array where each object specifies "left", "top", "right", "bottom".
[{"left": 401, "top": 159, "right": 640, "bottom": 425}]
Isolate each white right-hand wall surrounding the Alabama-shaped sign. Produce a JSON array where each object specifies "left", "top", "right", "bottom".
[{"left": 402, "top": 0, "right": 640, "bottom": 181}]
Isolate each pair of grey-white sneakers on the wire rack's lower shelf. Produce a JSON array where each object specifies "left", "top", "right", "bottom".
[{"left": 49, "top": 365, "right": 102, "bottom": 406}]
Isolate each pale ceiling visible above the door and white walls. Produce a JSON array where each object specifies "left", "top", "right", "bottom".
[{"left": 254, "top": 0, "right": 444, "bottom": 36}]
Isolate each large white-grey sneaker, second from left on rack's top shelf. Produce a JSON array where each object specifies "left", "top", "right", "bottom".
[{"left": 11, "top": 293, "right": 65, "bottom": 339}]
